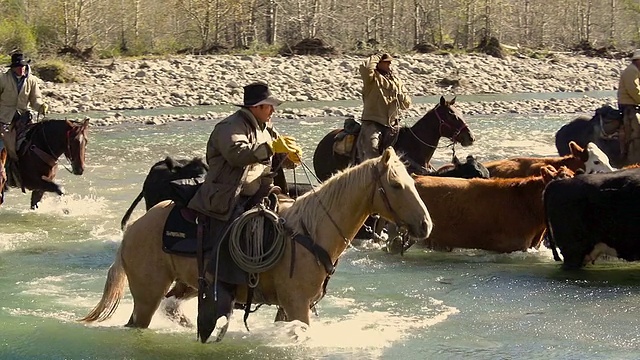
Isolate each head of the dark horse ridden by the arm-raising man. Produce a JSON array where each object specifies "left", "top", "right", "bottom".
[{"left": 431, "top": 96, "right": 475, "bottom": 146}]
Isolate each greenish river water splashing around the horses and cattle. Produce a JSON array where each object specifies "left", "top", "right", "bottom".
[{"left": 0, "top": 102, "right": 640, "bottom": 360}]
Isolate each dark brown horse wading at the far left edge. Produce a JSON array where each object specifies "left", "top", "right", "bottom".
[{"left": 11, "top": 119, "right": 89, "bottom": 209}]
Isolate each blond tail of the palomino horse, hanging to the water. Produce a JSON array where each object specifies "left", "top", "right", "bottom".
[{"left": 78, "top": 244, "right": 127, "bottom": 322}]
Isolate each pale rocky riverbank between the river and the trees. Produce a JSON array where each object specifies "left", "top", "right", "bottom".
[{"left": 43, "top": 54, "right": 627, "bottom": 126}]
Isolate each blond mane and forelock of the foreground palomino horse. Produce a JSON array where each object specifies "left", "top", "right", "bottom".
[{"left": 281, "top": 150, "right": 406, "bottom": 238}]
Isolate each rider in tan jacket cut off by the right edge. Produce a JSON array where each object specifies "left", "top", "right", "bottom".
[{"left": 618, "top": 49, "right": 640, "bottom": 164}]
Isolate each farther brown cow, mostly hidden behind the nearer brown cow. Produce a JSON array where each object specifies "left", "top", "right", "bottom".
[{"left": 482, "top": 141, "right": 589, "bottom": 178}]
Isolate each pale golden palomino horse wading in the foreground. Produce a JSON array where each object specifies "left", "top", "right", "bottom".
[{"left": 82, "top": 148, "right": 432, "bottom": 338}]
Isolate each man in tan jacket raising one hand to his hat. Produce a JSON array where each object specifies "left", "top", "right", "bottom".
[{"left": 357, "top": 54, "right": 411, "bottom": 161}]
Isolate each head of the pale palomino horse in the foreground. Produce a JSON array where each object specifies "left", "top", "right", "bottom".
[{"left": 373, "top": 147, "right": 433, "bottom": 239}]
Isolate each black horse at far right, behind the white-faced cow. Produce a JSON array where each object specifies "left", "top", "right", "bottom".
[{"left": 556, "top": 105, "right": 627, "bottom": 167}]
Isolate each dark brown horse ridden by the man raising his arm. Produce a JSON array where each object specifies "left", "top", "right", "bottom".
[{"left": 313, "top": 97, "right": 475, "bottom": 181}]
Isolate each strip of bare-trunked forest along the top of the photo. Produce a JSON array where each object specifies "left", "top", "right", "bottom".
[{"left": 0, "top": 0, "right": 640, "bottom": 58}]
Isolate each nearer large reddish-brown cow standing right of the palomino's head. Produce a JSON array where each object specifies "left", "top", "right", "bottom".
[{"left": 415, "top": 166, "right": 573, "bottom": 253}]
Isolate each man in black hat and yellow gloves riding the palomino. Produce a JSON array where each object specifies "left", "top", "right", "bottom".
[{"left": 188, "top": 83, "right": 301, "bottom": 342}]
